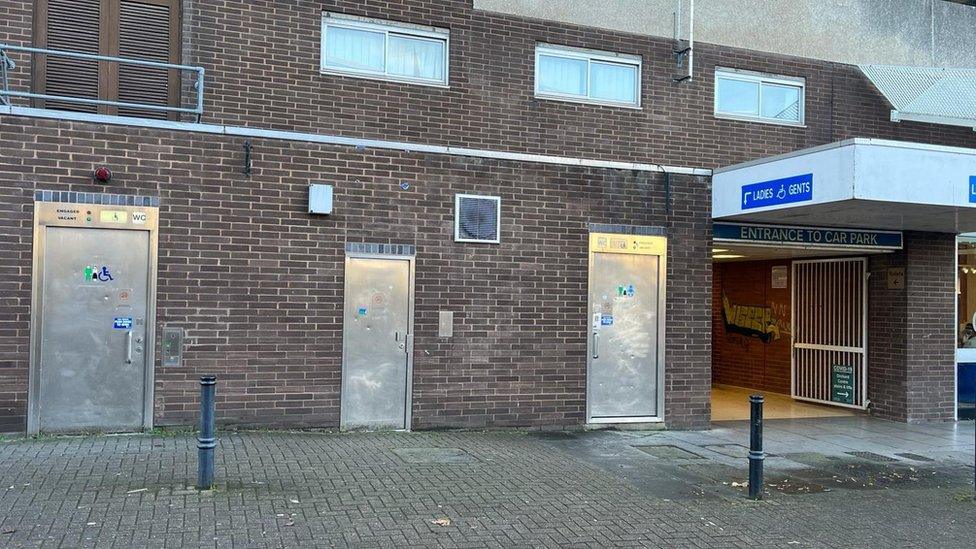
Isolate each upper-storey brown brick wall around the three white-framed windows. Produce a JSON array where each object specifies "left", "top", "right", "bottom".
[{"left": 0, "top": 0, "right": 976, "bottom": 167}]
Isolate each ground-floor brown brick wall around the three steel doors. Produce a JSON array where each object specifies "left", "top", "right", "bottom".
[{"left": 0, "top": 117, "right": 711, "bottom": 427}]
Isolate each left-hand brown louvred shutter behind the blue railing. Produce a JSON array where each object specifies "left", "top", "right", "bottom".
[{"left": 35, "top": 0, "right": 102, "bottom": 112}]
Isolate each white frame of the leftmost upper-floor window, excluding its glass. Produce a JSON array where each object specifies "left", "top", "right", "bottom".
[{"left": 319, "top": 12, "right": 451, "bottom": 88}]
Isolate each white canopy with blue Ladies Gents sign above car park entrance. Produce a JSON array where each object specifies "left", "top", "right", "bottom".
[{"left": 712, "top": 139, "right": 976, "bottom": 233}]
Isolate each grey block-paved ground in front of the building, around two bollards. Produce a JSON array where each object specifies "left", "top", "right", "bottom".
[{"left": 0, "top": 417, "right": 976, "bottom": 547}]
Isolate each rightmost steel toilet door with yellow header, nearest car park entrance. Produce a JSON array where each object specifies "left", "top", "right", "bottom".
[{"left": 588, "top": 235, "right": 664, "bottom": 423}]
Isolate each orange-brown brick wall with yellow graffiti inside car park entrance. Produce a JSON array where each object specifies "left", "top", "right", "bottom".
[{"left": 712, "top": 260, "right": 791, "bottom": 394}]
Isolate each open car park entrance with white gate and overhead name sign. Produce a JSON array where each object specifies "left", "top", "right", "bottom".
[{"left": 712, "top": 223, "right": 902, "bottom": 421}]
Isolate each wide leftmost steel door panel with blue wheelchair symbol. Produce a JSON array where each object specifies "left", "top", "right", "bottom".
[{"left": 37, "top": 227, "right": 150, "bottom": 432}]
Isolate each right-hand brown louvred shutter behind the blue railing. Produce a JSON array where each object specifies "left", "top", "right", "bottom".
[{"left": 117, "top": 0, "right": 179, "bottom": 118}]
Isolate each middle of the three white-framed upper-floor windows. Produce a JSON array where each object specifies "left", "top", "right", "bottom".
[{"left": 535, "top": 44, "right": 641, "bottom": 108}]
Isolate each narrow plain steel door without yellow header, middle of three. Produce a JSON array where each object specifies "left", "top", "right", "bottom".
[{"left": 340, "top": 256, "right": 413, "bottom": 429}]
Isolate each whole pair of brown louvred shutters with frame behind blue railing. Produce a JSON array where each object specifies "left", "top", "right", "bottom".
[{"left": 32, "top": 0, "right": 181, "bottom": 118}]
